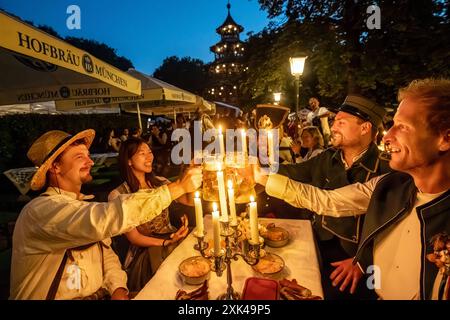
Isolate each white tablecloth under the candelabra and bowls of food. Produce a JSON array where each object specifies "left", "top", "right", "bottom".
[{"left": 135, "top": 215, "right": 323, "bottom": 300}]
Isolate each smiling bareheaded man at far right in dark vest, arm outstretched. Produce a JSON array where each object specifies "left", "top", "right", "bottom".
[{"left": 254, "top": 78, "right": 450, "bottom": 300}]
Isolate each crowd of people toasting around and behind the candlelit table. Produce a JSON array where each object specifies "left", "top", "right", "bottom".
[{"left": 10, "top": 79, "right": 450, "bottom": 299}]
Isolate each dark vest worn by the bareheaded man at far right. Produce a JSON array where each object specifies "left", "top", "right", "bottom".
[{"left": 355, "top": 172, "right": 450, "bottom": 299}]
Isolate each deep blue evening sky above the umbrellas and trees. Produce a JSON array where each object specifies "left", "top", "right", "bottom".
[{"left": 0, "top": 0, "right": 269, "bottom": 74}]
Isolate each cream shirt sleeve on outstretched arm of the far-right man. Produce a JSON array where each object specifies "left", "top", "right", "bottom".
[{"left": 266, "top": 174, "right": 382, "bottom": 217}]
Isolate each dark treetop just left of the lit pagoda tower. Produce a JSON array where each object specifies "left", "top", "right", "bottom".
[{"left": 153, "top": 56, "right": 208, "bottom": 95}]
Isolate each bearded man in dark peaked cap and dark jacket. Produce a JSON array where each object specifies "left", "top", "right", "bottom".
[{"left": 269, "top": 95, "right": 389, "bottom": 299}]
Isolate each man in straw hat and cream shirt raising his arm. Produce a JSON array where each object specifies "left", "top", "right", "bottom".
[{"left": 10, "top": 129, "right": 201, "bottom": 299}]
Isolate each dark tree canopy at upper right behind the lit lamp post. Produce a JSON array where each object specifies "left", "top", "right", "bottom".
[{"left": 250, "top": 0, "right": 450, "bottom": 106}]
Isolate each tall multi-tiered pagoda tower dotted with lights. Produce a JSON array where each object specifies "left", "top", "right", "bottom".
[{"left": 208, "top": 1, "right": 245, "bottom": 104}]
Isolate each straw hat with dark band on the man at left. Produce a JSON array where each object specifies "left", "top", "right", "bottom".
[{"left": 27, "top": 129, "right": 95, "bottom": 190}]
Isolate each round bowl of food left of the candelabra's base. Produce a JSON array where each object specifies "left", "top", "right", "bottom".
[{"left": 178, "top": 256, "right": 211, "bottom": 285}]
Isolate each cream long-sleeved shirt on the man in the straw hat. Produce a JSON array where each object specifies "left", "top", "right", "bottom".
[{"left": 10, "top": 186, "right": 172, "bottom": 299}]
